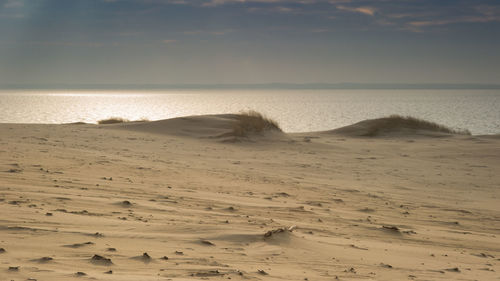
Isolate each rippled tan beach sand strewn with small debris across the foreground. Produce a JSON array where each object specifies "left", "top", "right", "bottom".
[{"left": 0, "top": 115, "right": 500, "bottom": 281}]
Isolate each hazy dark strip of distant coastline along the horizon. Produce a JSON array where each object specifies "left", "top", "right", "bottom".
[{"left": 0, "top": 83, "right": 500, "bottom": 90}]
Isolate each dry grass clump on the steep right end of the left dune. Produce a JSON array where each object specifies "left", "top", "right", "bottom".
[{"left": 233, "top": 110, "right": 283, "bottom": 137}]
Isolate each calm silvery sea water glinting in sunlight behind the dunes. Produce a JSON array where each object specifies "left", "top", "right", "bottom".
[{"left": 0, "top": 90, "right": 500, "bottom": 134}]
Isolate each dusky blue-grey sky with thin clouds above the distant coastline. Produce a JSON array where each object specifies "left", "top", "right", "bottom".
[{"left": 0, "top": 0, "right": 500, "bottom": 86}]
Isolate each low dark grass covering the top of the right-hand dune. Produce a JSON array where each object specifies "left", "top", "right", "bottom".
[{"left": 366, "top": 115, "right": 471, "bottom": 136}]
